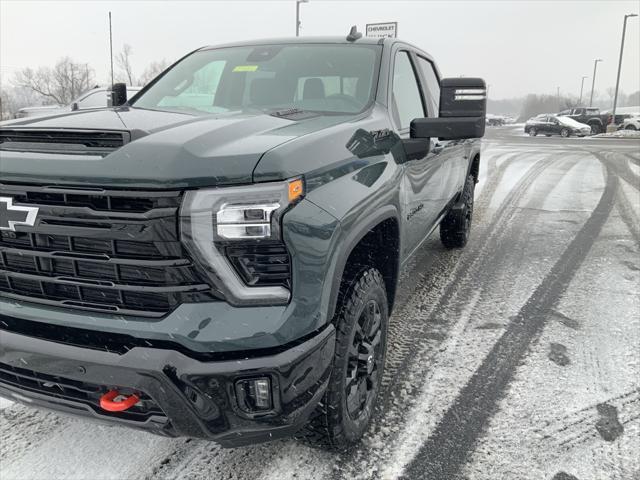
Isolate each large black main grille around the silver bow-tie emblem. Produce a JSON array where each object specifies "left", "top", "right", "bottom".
[{"left": 0, "top": 184, "right": 218, "bottom": 317}]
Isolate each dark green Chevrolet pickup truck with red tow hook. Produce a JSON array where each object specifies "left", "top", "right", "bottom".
[{"left": 0, "top": 30, "right": 486, "bottom": 449}]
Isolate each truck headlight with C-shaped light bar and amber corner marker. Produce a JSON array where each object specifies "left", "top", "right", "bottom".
[{"left": 180, "top": 178, "right": 304, "bottom": 305}]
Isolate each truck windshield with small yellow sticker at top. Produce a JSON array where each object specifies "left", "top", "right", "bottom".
[{"left": 133, "top": 44, "right": 381, "bottom": 114}]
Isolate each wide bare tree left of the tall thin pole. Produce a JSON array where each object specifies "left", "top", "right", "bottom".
[{"left": 12, "top": 57, "right": 94, "bottom": 105}]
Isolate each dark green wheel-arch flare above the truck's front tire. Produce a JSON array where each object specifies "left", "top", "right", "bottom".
[{"left": 327, "top": 205, "right": 402, "bottom": 322}]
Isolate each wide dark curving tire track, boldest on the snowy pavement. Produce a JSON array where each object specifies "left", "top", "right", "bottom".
[{"left": 403, "top": 159, "right": 618, "bottom": 480}]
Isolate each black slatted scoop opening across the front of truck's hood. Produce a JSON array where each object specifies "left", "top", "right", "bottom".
[{"left": 0, "top": 128, "right": 129, "bottom": 155}]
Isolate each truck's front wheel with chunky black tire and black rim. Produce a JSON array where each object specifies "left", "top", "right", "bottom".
[{"left": 296, "top": 268, "right": 389, "bottom": 451}]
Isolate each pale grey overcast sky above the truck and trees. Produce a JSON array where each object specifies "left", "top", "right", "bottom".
[{"left": 0, "top": 0, "right": 640, "bottom": 99}]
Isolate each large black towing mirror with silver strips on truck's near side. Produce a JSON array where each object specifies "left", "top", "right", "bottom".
[{"left": 411, "top": 77, "right": 487, "bottom": 140}]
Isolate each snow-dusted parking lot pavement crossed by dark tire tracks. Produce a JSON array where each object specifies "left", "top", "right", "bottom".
[{"left": 0, "top": 127, "right": 640, "bottom": 480}]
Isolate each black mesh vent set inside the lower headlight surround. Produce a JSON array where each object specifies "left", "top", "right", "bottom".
[{"left": 226, "top": 243, "right": 291, "bottom": 288}]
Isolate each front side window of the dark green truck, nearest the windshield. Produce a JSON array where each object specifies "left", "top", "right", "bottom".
[{"left": 391, "top": 52, "right": 425, "bottom": 130}]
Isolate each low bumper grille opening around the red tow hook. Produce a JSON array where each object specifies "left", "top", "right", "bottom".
[{"left": 0, "top": 363, "right": 165, "bottom": 422}]
